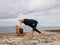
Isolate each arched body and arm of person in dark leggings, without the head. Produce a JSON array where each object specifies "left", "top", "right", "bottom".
[{"left": 16, "top": 19, "right": 41, "bottom": 36}]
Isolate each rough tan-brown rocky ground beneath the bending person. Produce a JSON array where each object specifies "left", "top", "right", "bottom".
[{"left": 0, "top": 31, "right": 60, "bottom": 45}]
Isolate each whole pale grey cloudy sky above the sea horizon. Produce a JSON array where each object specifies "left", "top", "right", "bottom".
[{"left": 0, "top": 0, "right": 60, "bottom": 27}]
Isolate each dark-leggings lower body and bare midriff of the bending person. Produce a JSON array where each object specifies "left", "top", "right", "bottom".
[{"left": 19, "top": 19, "right": 41, "bottom": 36}]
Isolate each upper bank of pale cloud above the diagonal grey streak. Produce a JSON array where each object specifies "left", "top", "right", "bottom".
[{"left": 0, "top": 0, "right": 60, "bottom": 19}]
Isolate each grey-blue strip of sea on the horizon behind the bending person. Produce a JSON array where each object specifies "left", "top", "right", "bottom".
[{"left": 0, "top": 26, "right": 60, "bottom": 33}]
